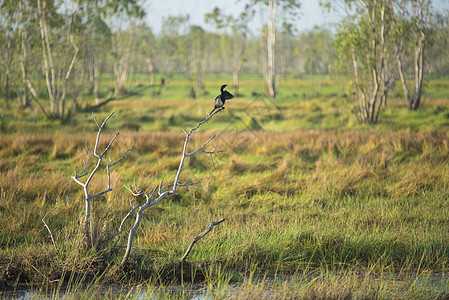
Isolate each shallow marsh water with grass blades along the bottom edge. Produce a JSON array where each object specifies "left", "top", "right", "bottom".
[{"left": 0, "top": 273, "right": 449, "bottom": 300}]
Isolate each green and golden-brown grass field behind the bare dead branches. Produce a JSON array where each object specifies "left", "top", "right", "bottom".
[{"left": 0, "top": 75, "right": 449, "bottom": 299}]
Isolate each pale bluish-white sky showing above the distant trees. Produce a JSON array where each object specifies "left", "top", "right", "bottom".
[{"left": 145, "top": 0, "right": 340, "bottom": 34}]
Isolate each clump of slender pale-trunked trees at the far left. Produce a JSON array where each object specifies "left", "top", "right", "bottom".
[{"left": 0, "top": 0, "right": 143, "bottom": 119}]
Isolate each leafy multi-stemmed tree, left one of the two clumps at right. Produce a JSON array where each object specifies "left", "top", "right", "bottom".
[{"left": 335, "top": 0, "right": 397, "bottom": 124}]
